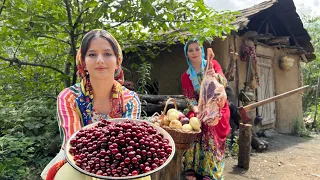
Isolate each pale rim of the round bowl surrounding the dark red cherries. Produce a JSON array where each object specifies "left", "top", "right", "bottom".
[{"left": 64, "top": 118, "right": 176, "bottom": 180}]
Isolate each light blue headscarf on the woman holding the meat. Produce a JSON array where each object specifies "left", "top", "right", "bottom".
[{"left": 184, "top": 39, "right": 207, "bottom": 92}]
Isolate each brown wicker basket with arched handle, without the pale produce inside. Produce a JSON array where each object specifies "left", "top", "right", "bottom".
[{"left": 160, "top": 98, "right": 201, "bottom": 149}]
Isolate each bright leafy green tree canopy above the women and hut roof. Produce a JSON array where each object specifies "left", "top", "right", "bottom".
[{"left": 0, "top": 0, "right": 235, "bottom": 87}]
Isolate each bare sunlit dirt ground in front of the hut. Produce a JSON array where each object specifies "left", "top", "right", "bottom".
[{"left": 224, "top": 133, "right": 320, "bottom": 180}]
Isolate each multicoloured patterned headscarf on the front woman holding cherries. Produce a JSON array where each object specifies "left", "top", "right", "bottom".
[{"left": 76, "top": 29, "right": 124, "bottom": 126}]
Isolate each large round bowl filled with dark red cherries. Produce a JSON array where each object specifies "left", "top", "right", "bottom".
[{"left": 65, "top": 118, "right": 175, "bottom": 179}]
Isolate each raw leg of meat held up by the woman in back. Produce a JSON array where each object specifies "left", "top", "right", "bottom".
[{"left": 198, "top": 48, "right": 227, "bottom": 126}]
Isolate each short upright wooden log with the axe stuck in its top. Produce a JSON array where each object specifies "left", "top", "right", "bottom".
[{"left": 238, "top": 123, "right": 252, "bottom": 169}]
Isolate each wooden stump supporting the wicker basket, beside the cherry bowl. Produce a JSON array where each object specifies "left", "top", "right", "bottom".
[{"left": 151, "top": 149, "right": 185, "bottom": 180}]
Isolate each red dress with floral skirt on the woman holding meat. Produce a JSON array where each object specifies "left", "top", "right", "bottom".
[{"left": 181, "top": 60, "right": 230, "bottom": 180}]
